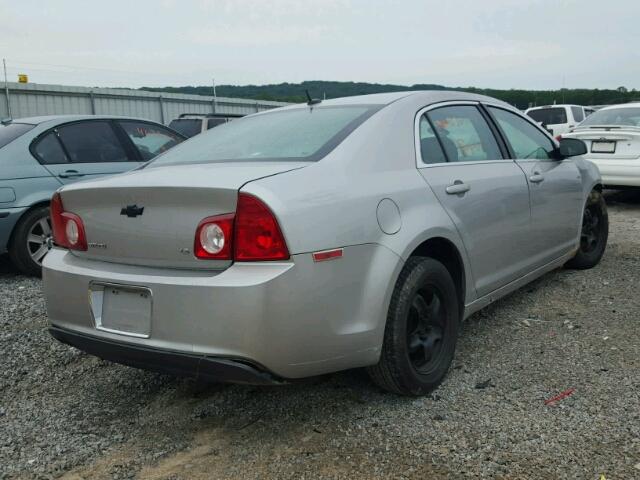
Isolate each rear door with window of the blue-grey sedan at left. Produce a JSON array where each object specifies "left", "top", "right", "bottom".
[{"left": 32, "top": 120, "right": 141, "bottom": 183}]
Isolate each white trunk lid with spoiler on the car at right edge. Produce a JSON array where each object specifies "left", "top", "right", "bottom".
[{"left": 565, "top": 125, "right": 640, "bottom": 160}]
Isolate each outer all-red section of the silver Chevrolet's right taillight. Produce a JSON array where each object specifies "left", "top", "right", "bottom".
[{"left": 234, "top": 193, "right": 289, "bottom": 262}]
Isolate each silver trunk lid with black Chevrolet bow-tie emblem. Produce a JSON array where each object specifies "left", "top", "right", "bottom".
[{"left": 61, "top": 162, "right": 308, "bottom": 270}]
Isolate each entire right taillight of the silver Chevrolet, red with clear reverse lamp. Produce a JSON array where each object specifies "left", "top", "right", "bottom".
[{"left": 194, "top": 193, "right": 289, "bottom": 262}]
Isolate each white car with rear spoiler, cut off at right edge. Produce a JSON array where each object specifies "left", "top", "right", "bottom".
[{"left": 563, "top": 102, "right": 640, "bottom": 188}]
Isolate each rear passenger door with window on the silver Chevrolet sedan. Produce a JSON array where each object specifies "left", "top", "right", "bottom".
[{"left": 416, "top": 103, "right": 530, "bottom": 296}]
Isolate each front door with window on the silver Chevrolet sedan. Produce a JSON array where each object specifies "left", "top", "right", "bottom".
[{"left": 488, "top": 106, "right": 583, "bottom": 266}]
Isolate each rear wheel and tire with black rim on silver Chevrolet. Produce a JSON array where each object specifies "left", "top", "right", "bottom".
[{"left": 367, "top": 257, "right": 461, "bottom": 396}]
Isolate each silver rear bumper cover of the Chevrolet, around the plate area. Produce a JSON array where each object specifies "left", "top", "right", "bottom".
[{"left": 43, "top": 244, "right": 402, "bottom": 379}]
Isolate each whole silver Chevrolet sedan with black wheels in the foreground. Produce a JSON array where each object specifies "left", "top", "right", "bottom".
[{"left": 44, "top": 91, "right": 608, "bottom": 395}]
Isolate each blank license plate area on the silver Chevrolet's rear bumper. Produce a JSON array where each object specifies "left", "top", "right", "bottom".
[{"left": 89, "top": 283, "right": 152, "bottom": 338}]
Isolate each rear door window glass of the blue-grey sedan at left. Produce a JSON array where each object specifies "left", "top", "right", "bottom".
[{"left": 58, "top": 121, "right": 129, "bottom": 163}]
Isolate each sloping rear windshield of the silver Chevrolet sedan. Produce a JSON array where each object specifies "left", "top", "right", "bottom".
[{"left": 150, "top": 105, "right": 380, "bottom": 166}]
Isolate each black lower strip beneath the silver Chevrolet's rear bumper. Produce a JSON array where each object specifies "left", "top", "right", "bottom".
[{"left": 49, "top": 326, "right": 282, "bottom": 385}]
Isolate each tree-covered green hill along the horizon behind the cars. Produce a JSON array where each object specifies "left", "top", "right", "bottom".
[{"left": 141, "top": 80, "right": 640, "bottom": 109}]
